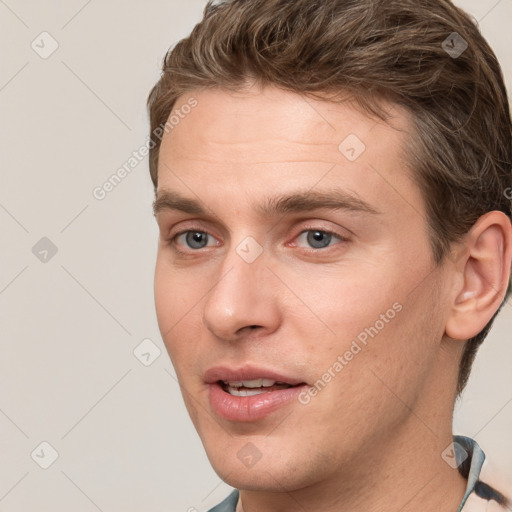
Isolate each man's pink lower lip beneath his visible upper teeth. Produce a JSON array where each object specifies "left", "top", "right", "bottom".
[{"left": 209, "top": 382, "right": 307, "bottom": 421}]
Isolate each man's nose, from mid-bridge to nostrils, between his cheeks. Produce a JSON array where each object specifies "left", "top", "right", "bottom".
[{"left": 203, "top": 243, "right": 280, "bottom": 341}]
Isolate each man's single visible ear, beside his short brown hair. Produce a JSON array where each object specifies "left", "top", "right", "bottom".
[{"left": 445, "top": 211, "right": 512, "bottom": 340}]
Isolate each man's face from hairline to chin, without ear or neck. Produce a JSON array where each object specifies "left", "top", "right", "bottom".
[{"left": 155, "top": 87, "right": 452, "bottom": 491}]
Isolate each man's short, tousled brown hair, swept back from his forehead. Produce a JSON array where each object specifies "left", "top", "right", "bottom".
[{"left": 148, "top": 0, "right": 512, "bottom": 393}]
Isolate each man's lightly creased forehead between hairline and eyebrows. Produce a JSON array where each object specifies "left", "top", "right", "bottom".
[{"left": 158, "top": 86, "right": 422, "bottom": 220}]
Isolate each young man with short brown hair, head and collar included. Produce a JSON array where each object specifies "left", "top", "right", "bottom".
[{"left": 148, "top": 0, "right": 512, "bottom": 512}]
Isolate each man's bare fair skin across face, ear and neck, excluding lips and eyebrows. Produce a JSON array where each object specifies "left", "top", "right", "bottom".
[{"left": 155, "top": 85, "right": 511, "bottom": 512}]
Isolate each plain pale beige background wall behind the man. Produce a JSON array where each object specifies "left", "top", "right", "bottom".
[{"left": 0, "top": 0, "right": 512, "bottom": 512}]
